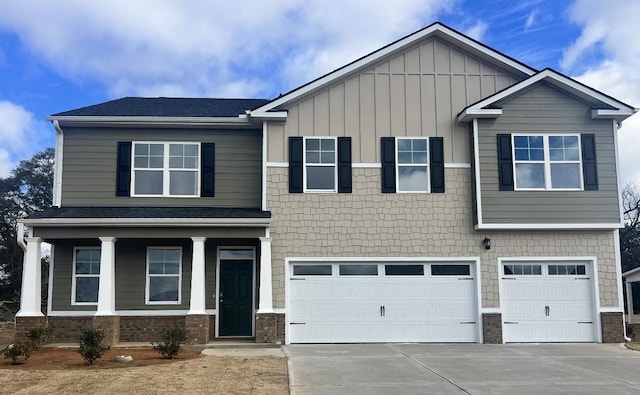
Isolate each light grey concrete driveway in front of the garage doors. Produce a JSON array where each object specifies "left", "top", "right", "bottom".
[{"left": 283, "top": 344, "right": 640, "bottom": 395}]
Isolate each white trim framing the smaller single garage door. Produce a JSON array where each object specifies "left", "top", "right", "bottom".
[{"left": 497, "top": 256, "right": 603, "bottom": 343}]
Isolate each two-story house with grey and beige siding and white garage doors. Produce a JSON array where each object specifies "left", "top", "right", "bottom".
[{"left": 16, "top": 23, "right": 635, "bottom": 343}]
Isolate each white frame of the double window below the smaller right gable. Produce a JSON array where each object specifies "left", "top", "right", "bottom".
[{"left": 511, "top": 133, "right": 584, "bottom": 191}]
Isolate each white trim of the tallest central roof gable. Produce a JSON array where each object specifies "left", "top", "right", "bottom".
[{"left": 250, "top": 22, "right": 536, "bottom": 118}]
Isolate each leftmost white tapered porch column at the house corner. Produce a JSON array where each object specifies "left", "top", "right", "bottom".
[{"left": 16, "top": 237, "right": 44, "bottom": 317}]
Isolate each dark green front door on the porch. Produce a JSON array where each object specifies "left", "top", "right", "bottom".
[{"left": 218, "top": 259, "right": 253, "bottom": 336}]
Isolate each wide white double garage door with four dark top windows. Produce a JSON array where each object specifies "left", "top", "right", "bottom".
[{"left": 289, "top": 263, "right": 477, "bottom": 343}]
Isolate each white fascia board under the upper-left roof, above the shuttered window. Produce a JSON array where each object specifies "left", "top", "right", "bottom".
[{"left": 45, "top": 114, "right": 251, "bottom": 126}]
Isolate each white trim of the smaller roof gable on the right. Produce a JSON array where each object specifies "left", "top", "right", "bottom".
[{"left": 458, "top": 68, "right": 636, "bottom": 122}]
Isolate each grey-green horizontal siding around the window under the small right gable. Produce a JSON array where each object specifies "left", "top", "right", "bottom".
[{"left": 478, "top": 84, "right": 620, "bottom": 224}]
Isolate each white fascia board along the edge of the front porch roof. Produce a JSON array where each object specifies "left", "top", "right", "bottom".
[{"left": 20, "top": 218, "right": 271, "bottom": 228}]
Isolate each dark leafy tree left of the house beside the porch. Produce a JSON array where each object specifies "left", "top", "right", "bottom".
[{"left": 0, "top": 148, "right": 54, "bottom": 301}]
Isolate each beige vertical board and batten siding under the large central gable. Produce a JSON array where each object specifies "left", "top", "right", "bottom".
[{"left": 267, "top": 39, "right": 519, "bottom": 163}]
